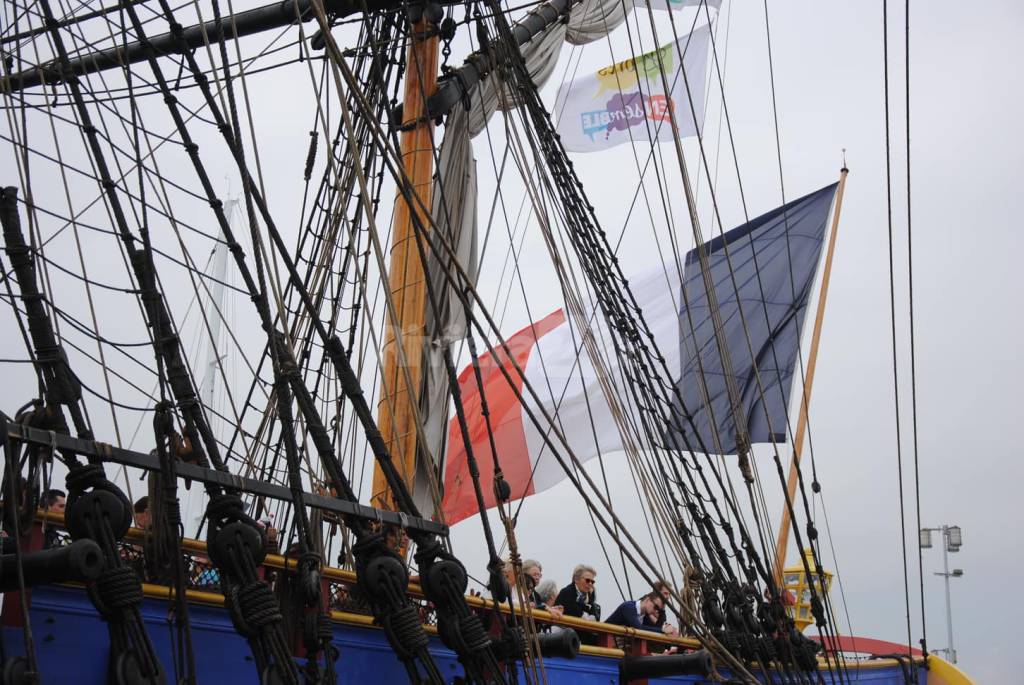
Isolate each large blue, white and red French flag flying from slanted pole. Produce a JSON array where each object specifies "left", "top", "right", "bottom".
[{"left": 442, "top": 184, "right": 836, "bottom": 524}]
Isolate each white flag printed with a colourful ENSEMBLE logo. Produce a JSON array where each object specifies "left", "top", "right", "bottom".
[{"left": 555, "top": 26, "right": 711, "bottom": 153}]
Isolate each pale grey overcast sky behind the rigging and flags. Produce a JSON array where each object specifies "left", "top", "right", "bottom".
[{"left": 0, "top": 0, "right": 1024, "bottom": 683}]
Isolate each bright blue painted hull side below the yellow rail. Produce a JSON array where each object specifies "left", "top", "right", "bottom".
[{"left": 4, "top": 586, "right": 928, "bottom": 685}]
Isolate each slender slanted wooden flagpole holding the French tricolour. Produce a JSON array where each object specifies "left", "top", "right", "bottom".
[{"left": 773, "top": 166, "right": 850, "bottom": 588}]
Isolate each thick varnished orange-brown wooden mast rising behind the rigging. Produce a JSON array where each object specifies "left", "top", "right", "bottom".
[{"left": 372, "top": 17, "right": 438, "bottom": 511}]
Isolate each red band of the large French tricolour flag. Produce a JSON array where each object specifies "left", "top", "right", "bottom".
[{"left": 441, "top": 309, "right": 565, "bottom": 525}]
